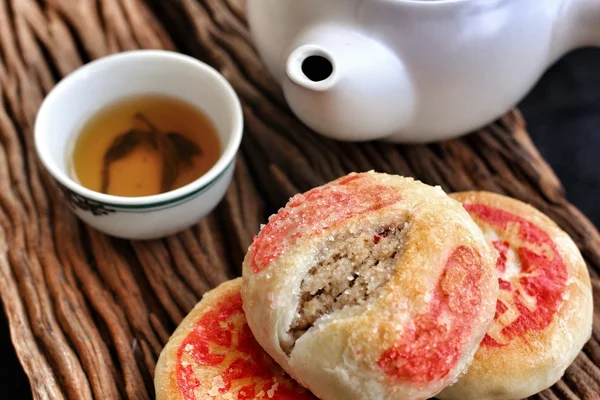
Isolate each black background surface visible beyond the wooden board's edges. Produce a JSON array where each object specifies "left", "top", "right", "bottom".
[{"left": 0, "top": 49, "right": 600, "bottom": 399}]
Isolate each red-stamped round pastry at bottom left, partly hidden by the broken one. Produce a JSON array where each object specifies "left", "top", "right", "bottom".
[{"left": 155, "top": 278, "right": 316, "bottom": 400}]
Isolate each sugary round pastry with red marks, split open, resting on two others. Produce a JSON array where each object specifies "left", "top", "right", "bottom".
[{"left": 242, "top": 172, "right": 498, "bottom": 400}]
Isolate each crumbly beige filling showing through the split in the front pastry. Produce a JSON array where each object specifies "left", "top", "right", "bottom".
[{"left": 289, "top": 228, "right": 403, "bottom": 341}]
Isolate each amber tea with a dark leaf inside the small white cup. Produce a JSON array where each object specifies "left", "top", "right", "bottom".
[{"left": 72, "top": 93, "right": 222, "bottom": 197}]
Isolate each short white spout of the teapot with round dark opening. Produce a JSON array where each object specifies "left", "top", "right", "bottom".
[{"left": 283, "top": 25, "right": 415, "bottom": 141}]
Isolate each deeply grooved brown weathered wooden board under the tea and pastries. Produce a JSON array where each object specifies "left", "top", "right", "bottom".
[{"left": 0, "top": 0, "right": 600, "bottom": 399}]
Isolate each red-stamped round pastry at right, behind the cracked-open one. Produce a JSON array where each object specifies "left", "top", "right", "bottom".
[{"left": 438, "top": 192, "right": 593, "bottom": 400}]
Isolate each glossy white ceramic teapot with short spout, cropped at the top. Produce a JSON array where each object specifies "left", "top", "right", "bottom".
[{"left": 248, "top": 0, "right": 600, "bottom": 142}]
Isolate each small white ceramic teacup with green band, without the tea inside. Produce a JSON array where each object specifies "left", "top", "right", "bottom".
[{"left": 35, "top": 50, "right": 243, "bottom": 239}]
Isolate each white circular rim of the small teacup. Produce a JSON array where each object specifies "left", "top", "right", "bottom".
[{"left": 34, "top": 49, "right": 244, "bottom": 207}]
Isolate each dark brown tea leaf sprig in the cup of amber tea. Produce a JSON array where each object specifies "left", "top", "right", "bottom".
[{"left": 101, "top": 113, "right": 202, "bottom": 193}]
